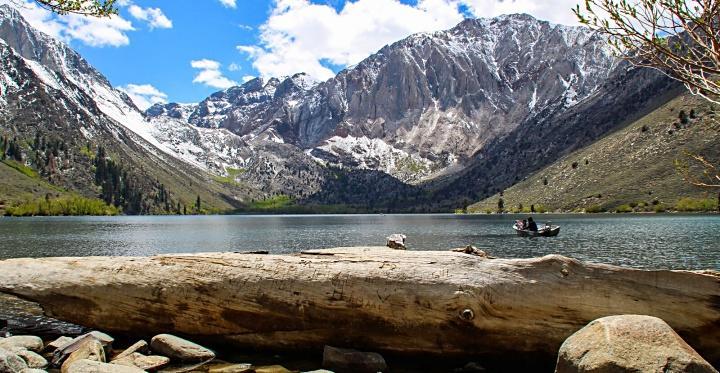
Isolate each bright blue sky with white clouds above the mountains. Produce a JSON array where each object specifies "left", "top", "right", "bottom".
[{"left": 0, "top": 0, "right": 578, "bottom": 108}]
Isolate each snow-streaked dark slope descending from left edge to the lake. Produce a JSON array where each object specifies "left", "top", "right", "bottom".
[{"left": 0, "top": 6, "right": 251, "bottom": 213}]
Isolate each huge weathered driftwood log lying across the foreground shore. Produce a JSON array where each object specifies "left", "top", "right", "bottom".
[{"left": 0, "top": 248, "right": 720, "bottom": 362}]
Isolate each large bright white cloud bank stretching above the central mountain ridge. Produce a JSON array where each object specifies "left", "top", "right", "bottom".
[{"left": 242, "top": 0, "right": 577, "bottom": 79}]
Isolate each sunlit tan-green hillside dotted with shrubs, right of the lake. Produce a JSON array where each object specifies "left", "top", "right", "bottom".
[{"left": 468, "top": 94, "right": 720, "bottom": 212}]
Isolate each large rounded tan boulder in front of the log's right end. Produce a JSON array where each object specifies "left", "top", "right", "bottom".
[{"left": 555, "top": 315, "right": 717, "bottom": 373}]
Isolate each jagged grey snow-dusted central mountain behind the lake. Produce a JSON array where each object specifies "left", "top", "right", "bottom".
[{"left": 146, "top": 15, "right": 617, "bottom": 192}]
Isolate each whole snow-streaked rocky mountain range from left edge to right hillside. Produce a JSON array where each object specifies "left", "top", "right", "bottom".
[{"left": 0, "top": 6, "right": 678, "bottom": 211}]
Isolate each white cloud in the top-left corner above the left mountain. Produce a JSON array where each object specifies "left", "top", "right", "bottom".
[{"left": 0, "top": 0, "right": 135, "bottom": 47}]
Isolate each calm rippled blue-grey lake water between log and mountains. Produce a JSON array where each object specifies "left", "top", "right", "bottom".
[{"left": 0, "top": 215, "right": 720, "bottom": 270}]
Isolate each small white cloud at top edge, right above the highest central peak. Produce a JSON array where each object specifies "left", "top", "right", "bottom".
[{"left": 460, "top": 0, "right": 582, "bottom": 25}]
